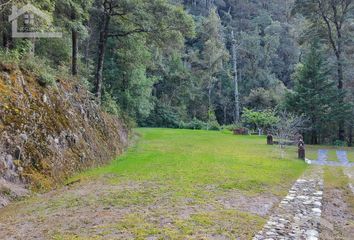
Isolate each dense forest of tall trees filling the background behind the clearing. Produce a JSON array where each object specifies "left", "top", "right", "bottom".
[{"left": 0, "top": 0, "right": 354, "bottom": 146}]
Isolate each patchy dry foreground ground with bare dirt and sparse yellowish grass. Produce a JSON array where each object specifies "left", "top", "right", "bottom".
[{"left": 0, "top": 174, "right": 280, "bottom": 240}]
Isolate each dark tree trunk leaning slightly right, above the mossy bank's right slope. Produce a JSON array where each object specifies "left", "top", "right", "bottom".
[{"left": 95, "top": 13, "right": 110, "bottom": 102}]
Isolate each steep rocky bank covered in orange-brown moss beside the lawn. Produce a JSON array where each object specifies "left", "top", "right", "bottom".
[{"left": 0, "top": 63, "right": 128, "bottom": 207}]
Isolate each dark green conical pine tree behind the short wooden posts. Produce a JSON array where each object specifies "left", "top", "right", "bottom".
[{"left": 286, "top": 43, "right": 347, "bottom": 144}]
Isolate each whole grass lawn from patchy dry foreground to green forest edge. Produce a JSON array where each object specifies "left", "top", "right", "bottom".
[{"left": 0, "top": 129, "right": 307, "bottom": 240}]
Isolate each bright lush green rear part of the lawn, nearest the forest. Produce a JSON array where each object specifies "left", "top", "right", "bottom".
[{"left": 74, "top": 129, "right": 306, "bottom": 195}]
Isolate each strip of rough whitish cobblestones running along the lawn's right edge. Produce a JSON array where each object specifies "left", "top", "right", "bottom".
[{"left": 253, "top": 167, "right": 323, "bottom": 240}]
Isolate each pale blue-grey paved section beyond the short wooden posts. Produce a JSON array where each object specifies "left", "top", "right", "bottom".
[{"left": 306, "top": 149, "right": 354, "bottom": 167}]
